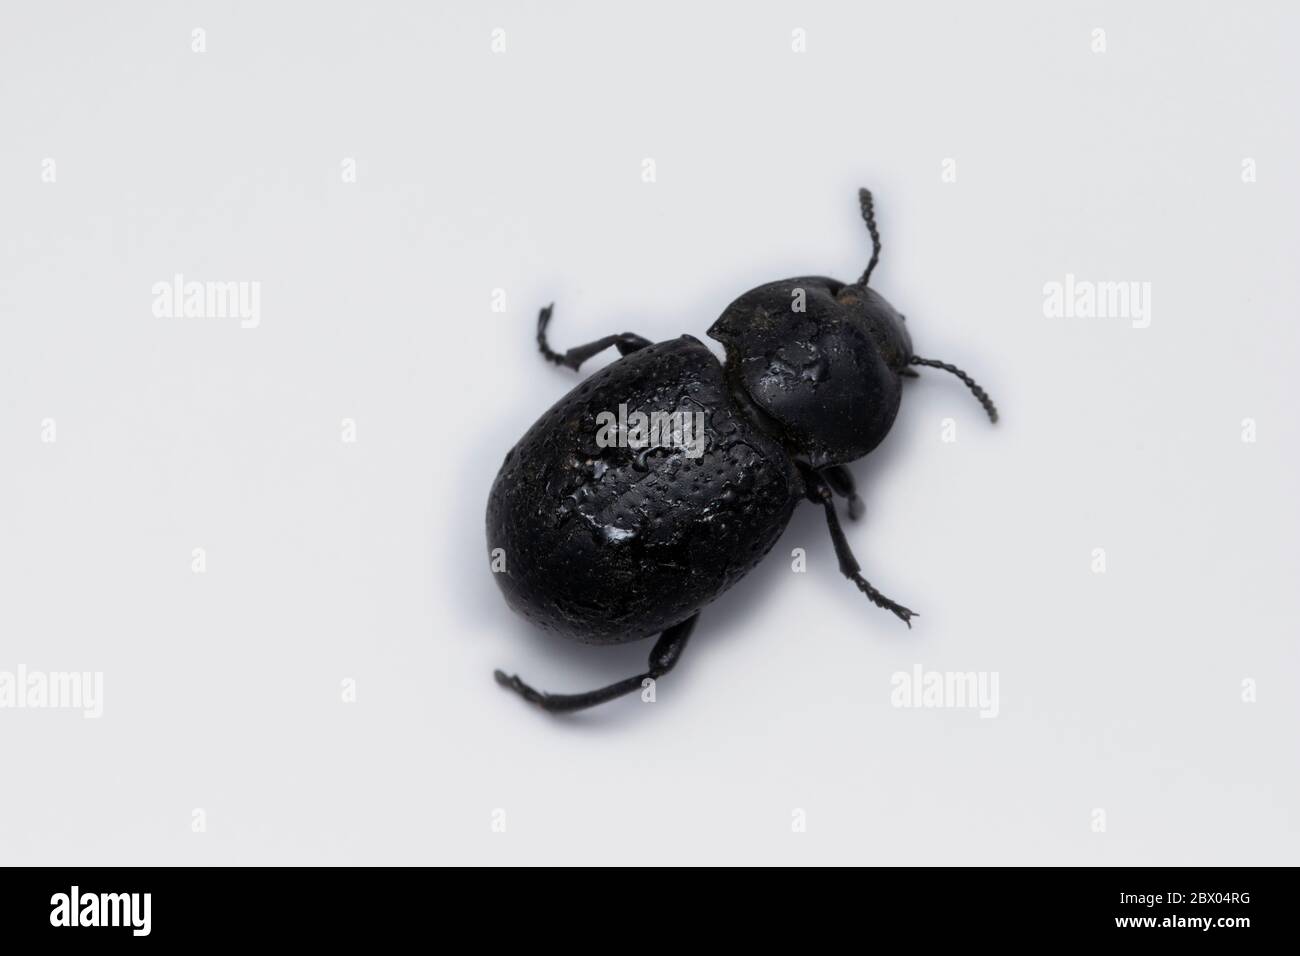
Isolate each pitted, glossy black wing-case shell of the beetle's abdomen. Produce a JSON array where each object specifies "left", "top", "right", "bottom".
[{"left": 488, "top": 336, "right": 803, "bottom": 644}]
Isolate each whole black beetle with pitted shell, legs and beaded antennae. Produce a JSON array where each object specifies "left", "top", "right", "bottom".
[{"left": 488, "top": 190, "right": 997, "bottom": 711}]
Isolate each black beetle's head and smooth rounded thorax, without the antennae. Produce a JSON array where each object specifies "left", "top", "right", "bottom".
[{"left": 709, "top": 276, "right": 911, "bottom": 468}]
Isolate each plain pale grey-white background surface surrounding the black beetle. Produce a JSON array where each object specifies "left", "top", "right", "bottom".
[{"left": 0, "top": 3, "right": 1300, "bottom": 864}]
